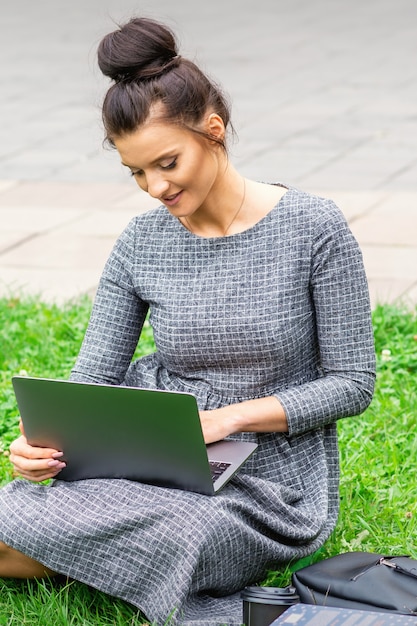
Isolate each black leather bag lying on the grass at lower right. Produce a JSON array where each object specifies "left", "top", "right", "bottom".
[{"left": 292, "top": 552, "right": 417, "bottom": 612}]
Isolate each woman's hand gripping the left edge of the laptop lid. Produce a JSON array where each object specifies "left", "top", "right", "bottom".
[{"left": 9, "top": 434, "right": 65, "bottom": 482}]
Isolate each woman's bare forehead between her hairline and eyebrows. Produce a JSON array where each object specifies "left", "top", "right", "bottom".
[{"left": 114, "top": 121, "right": 197, "bottom": 168}]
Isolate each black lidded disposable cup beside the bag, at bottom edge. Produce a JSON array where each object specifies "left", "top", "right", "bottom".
[{"left": 240, "top": 587, "right": 300, "bottom": 626}]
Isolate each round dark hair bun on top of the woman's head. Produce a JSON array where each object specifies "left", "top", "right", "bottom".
[{"left": 97, "top": 18, "right": 178, "bottom": 82}]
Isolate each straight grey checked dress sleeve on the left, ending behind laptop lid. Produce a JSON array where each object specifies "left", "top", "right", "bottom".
[{"left": 70, "top": 220, "right": 148, "bottom": 385}]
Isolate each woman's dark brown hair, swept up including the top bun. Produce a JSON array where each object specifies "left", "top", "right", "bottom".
[{"left": 98, "top": 18, "right": 231, "bottom": 148}]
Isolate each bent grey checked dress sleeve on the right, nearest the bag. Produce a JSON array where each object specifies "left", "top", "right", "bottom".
[{"left": 276, "top": 201, "right": 375, "bottom": 436}]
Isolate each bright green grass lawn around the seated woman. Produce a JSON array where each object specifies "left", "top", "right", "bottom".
[{"left": 0, "top": 298, "right": 417, "bottom": 626}]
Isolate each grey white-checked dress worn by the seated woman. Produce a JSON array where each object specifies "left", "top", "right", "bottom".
[{"left": 0, "top": 189, "right": 374, "bottom": 626}]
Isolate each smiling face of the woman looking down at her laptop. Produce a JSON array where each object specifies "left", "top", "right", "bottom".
[{"left": 114, "top": 121, "right": 222, "bottom": 217}]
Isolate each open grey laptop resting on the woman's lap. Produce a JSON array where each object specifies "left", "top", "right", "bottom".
[{"left": 12, "top": 376, "right": 257, "bottom": 495}]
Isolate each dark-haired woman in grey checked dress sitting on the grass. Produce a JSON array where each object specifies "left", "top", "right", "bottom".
[{"left": 0, "top": 19, "right": 374, "bottom": 625}]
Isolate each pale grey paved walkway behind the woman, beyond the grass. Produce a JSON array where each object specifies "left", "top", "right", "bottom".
[{"left": 0, "top": 0, "right": 417, "bottom": 305}]
